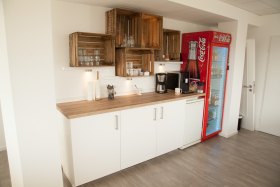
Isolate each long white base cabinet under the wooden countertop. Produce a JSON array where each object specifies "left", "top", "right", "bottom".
[{"left": 58, "top": 99, "right": 203, "bottom": 186}]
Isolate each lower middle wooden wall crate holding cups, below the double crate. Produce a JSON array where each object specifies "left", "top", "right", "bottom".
[{"left": 115, "top": 47, "right": 154, "bottom": 77}]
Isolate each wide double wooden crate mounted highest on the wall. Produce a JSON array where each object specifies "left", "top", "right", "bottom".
[{"left": 106, "top": 8, "right": 163, "bottom": 50}]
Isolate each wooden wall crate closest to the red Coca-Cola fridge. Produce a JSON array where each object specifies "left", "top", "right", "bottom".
[{"left": 155, "top": 29, "right": 181, "bottom": 61}]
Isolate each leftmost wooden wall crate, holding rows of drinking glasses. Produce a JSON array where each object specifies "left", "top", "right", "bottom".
[{"left": 69, "top": 32, "right": 115, "bottom": 67}]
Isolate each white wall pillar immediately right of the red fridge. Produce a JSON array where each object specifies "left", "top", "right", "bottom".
[{"left": 218, "top": 21, "right": 248, "bottom": 137}]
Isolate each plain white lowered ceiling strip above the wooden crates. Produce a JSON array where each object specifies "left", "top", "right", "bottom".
[{"left": 59, "top": 0, "right": 233, "bottom": 27}]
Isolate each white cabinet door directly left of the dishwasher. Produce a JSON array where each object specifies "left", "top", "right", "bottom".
[{"left": 157, "top": 100, "right": 186, "bottom": 156}]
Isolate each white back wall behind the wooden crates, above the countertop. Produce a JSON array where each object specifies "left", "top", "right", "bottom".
[{"left": 52, "top": 1, "right": 213, "bottom": 102}]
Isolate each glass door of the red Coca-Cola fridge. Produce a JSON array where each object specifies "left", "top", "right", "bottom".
[{"left": 206, "top": 46, "right": 228, "bottom": 136}]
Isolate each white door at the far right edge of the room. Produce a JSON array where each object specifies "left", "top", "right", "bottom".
[{"left": 260, "top": 36, "right": 280, "bottom": 136}]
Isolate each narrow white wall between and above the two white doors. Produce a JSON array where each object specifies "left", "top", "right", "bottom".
[{"left": 248, "top": 14, "right": 280, "bottom": 130}]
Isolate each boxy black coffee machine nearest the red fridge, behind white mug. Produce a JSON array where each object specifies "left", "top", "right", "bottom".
[{"left": 166, "top": 71, "right": 191, "bottom": 94}]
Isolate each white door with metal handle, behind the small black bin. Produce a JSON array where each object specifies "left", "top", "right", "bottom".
[{"left": 240, "top": 39, "right": 255, "bottom": 131}]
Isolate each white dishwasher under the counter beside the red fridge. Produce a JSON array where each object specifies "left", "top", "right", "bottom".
[{"left": 180, "top": 98, "right": 204, "bottom": 149}]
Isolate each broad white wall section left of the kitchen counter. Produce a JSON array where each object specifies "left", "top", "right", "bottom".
[{"left": 0, "top": 0, "right": 63, "bottom": 187}]
